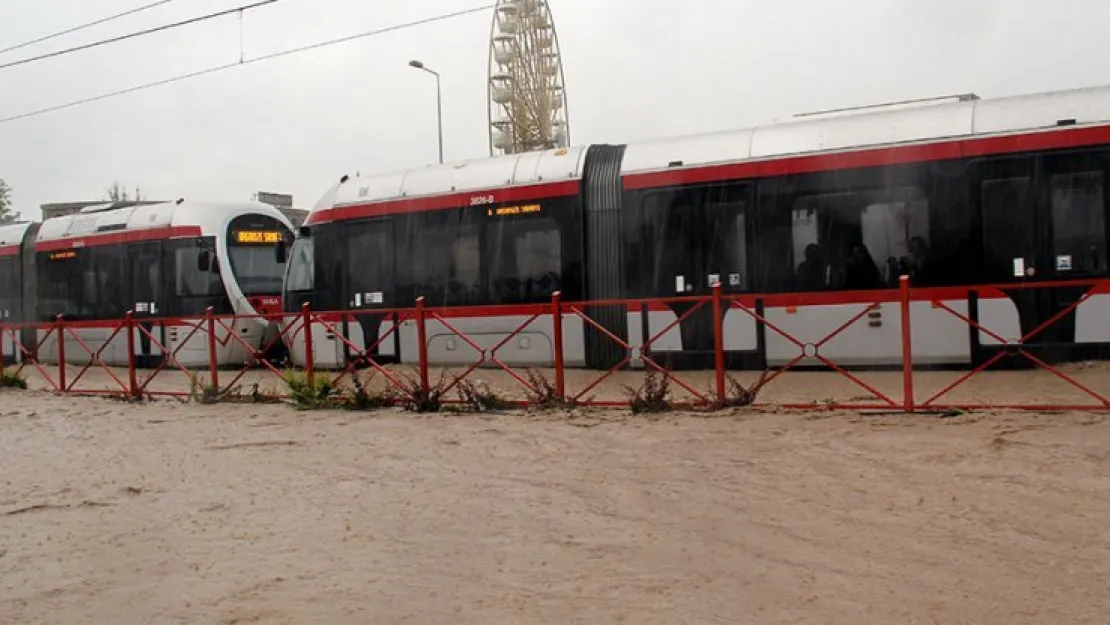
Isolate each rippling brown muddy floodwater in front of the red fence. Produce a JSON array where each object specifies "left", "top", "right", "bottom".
[{"left": 0, "top": 386, "right": 1110, "bottom": 625}]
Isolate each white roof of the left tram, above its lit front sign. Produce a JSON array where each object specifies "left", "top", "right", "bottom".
[{"left": 36, "top": 200, "right": 293, "bottom": 241}]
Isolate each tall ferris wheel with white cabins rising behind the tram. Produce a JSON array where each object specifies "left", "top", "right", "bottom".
[{"left": 488, "top": 0, "right": 571, "bottom": 155}]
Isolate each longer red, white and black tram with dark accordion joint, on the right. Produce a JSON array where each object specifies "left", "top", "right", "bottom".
[{"left": 284, "top": 80, "right": 1110, "bottom": 369}]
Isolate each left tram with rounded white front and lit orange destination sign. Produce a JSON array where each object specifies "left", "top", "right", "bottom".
[{"left": 0, "top": 200, "right": 293, "bottom": 367}]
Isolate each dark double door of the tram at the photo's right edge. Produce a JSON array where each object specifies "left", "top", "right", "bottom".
[{"left": 972, "top": 154, "right": 1110, "bottom": 362}]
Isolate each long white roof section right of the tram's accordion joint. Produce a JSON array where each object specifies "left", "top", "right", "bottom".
[{"left": 620, "top": 85, "right": 1110, "bottom": 174}]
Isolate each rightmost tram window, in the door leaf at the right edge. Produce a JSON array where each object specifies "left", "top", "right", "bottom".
[{"left": 1051, "top": 171, "right": 1107, "bottom": 274}]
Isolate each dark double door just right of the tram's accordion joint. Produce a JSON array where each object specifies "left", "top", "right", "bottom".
[{"left": 644, "top": 185, "right": 750, "bottom": 369}]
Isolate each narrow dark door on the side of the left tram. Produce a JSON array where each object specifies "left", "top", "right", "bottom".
[{"left": 128, "top": 243, "right": 165, "bottom": 367}]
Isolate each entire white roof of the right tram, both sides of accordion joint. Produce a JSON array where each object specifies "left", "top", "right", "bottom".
[{"left": 313, "top": 85, "right": 1110, "bottom": 211}]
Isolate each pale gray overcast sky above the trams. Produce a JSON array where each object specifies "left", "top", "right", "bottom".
[{"left": 0, "top": 0, "right": 1110, "bottom": 219}]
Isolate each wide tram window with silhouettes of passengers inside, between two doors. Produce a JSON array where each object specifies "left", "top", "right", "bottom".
[{"left": 791, "top": 187, "right": 929, "bottom": 291}]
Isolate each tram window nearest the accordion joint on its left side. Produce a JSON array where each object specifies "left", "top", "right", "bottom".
[{"left": 486, "top": 218, "right": 563, "bottom": 304}]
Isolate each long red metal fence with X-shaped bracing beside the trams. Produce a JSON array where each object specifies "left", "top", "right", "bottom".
[{"left": 0, "top": 279, "right": 1110, "bottom": 413}]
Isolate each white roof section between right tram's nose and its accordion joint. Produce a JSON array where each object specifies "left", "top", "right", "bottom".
[{"left": 313, "top": 145, "right": 586, "bottom": 210}]
